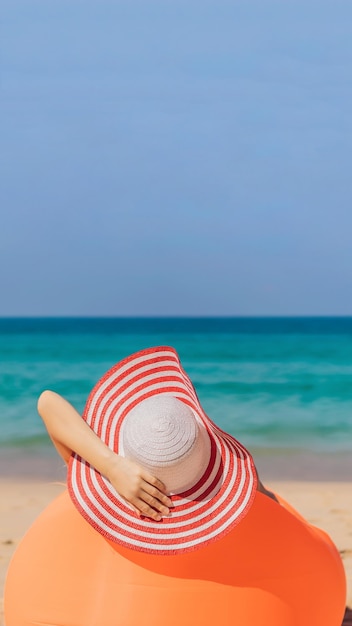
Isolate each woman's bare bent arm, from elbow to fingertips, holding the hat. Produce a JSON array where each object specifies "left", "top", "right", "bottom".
[{"left": 38, "top": 391, "right": 172, "bottom": 520}]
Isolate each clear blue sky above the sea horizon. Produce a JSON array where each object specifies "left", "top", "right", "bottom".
[{"left": 0, "top": 0, "right": 352, "bottom": 316}]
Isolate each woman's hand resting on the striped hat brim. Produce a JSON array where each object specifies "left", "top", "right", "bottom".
[{"left": 106, "top": 454, "right": 172, "bottom": 521}]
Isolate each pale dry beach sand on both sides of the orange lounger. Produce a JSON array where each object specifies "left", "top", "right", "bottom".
[{"left": 0, "top": 476, "right": 352, "bottom": 626}]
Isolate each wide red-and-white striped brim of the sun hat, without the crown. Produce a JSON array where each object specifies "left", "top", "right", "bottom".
[{"left": 68, "top": 347, "right": 257, "bottom": 554}]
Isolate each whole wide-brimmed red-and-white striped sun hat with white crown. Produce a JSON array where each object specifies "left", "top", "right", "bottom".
[{"left": 68, "top": 347, "right": 257, "bottom": 555}]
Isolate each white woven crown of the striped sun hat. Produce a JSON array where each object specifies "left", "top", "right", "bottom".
[{"left": 122, "top": 394, "right": 210, "bottom": 493}]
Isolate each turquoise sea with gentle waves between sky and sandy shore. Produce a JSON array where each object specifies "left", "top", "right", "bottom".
[{"left": 0, "top": 318, "right": 352, "bottom": 464}]
